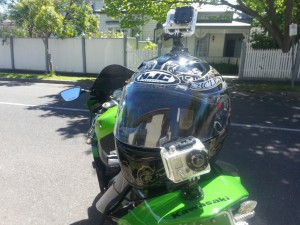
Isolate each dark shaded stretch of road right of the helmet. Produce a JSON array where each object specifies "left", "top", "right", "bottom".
[{"left": 220, "top": 86, "right": 300, "bottom": 225}]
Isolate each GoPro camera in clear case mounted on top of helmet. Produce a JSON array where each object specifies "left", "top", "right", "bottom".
[{"left": 164, "top": 6, "right": 197, "bottom": 36}]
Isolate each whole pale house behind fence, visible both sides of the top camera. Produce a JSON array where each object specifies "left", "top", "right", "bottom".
[{"left": 93, "top": 0, "right": 251, "bottom": 58}]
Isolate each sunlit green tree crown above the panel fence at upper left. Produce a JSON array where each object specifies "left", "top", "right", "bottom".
[{"left": 9, "top": 0, "right": 98, "bottom": 38}]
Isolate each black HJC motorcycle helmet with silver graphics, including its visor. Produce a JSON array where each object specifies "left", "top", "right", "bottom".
[{"left": 115, "top": 52, "right": 230, "bottom": 188}]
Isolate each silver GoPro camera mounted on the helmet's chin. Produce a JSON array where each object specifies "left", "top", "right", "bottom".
[{"left": 160, "top": 137, "right": 210, "bottom": 183}]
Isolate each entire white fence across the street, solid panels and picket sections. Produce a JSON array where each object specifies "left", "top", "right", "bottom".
[{"left": 0, "top": 35, "right": 300, "bottom": 80}]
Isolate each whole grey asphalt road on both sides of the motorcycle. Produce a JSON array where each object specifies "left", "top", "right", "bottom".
[{"left": 0, "top": 80, "right": 300, "bottom": 225}]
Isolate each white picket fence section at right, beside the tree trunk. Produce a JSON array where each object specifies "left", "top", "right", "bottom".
[{"left": 239, "top": 42, "right": 300, "bottom": 80}]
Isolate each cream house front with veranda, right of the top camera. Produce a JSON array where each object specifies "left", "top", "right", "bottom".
[{"left": 156, "top": 5, "right": 251, "bottom": 59}]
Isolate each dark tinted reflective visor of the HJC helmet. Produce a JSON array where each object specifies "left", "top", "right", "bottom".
[{"left": 115, "top": 83, "right": 229, "bottom": 148}]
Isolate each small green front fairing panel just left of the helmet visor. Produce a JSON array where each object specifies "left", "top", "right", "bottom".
[{"left": 95, "top": 106, "right": 118, "bottom": 141}]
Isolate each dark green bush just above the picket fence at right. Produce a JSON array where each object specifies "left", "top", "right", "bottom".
[{"left": 250, "top": 32, "right": 278, "bottom": 49}]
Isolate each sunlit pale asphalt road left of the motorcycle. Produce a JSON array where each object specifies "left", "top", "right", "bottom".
[{"left": 0, "top": 81, "right": 98, "bottom": 225}]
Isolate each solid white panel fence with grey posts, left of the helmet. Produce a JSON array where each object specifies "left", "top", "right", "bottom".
[{"left": 0, "top": 38, "right": 126, "bottom": 73}]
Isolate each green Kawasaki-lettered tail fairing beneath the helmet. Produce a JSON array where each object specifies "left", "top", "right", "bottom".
[{"left": 118, "top": 175, "right": 249, "bottom": 225}]
